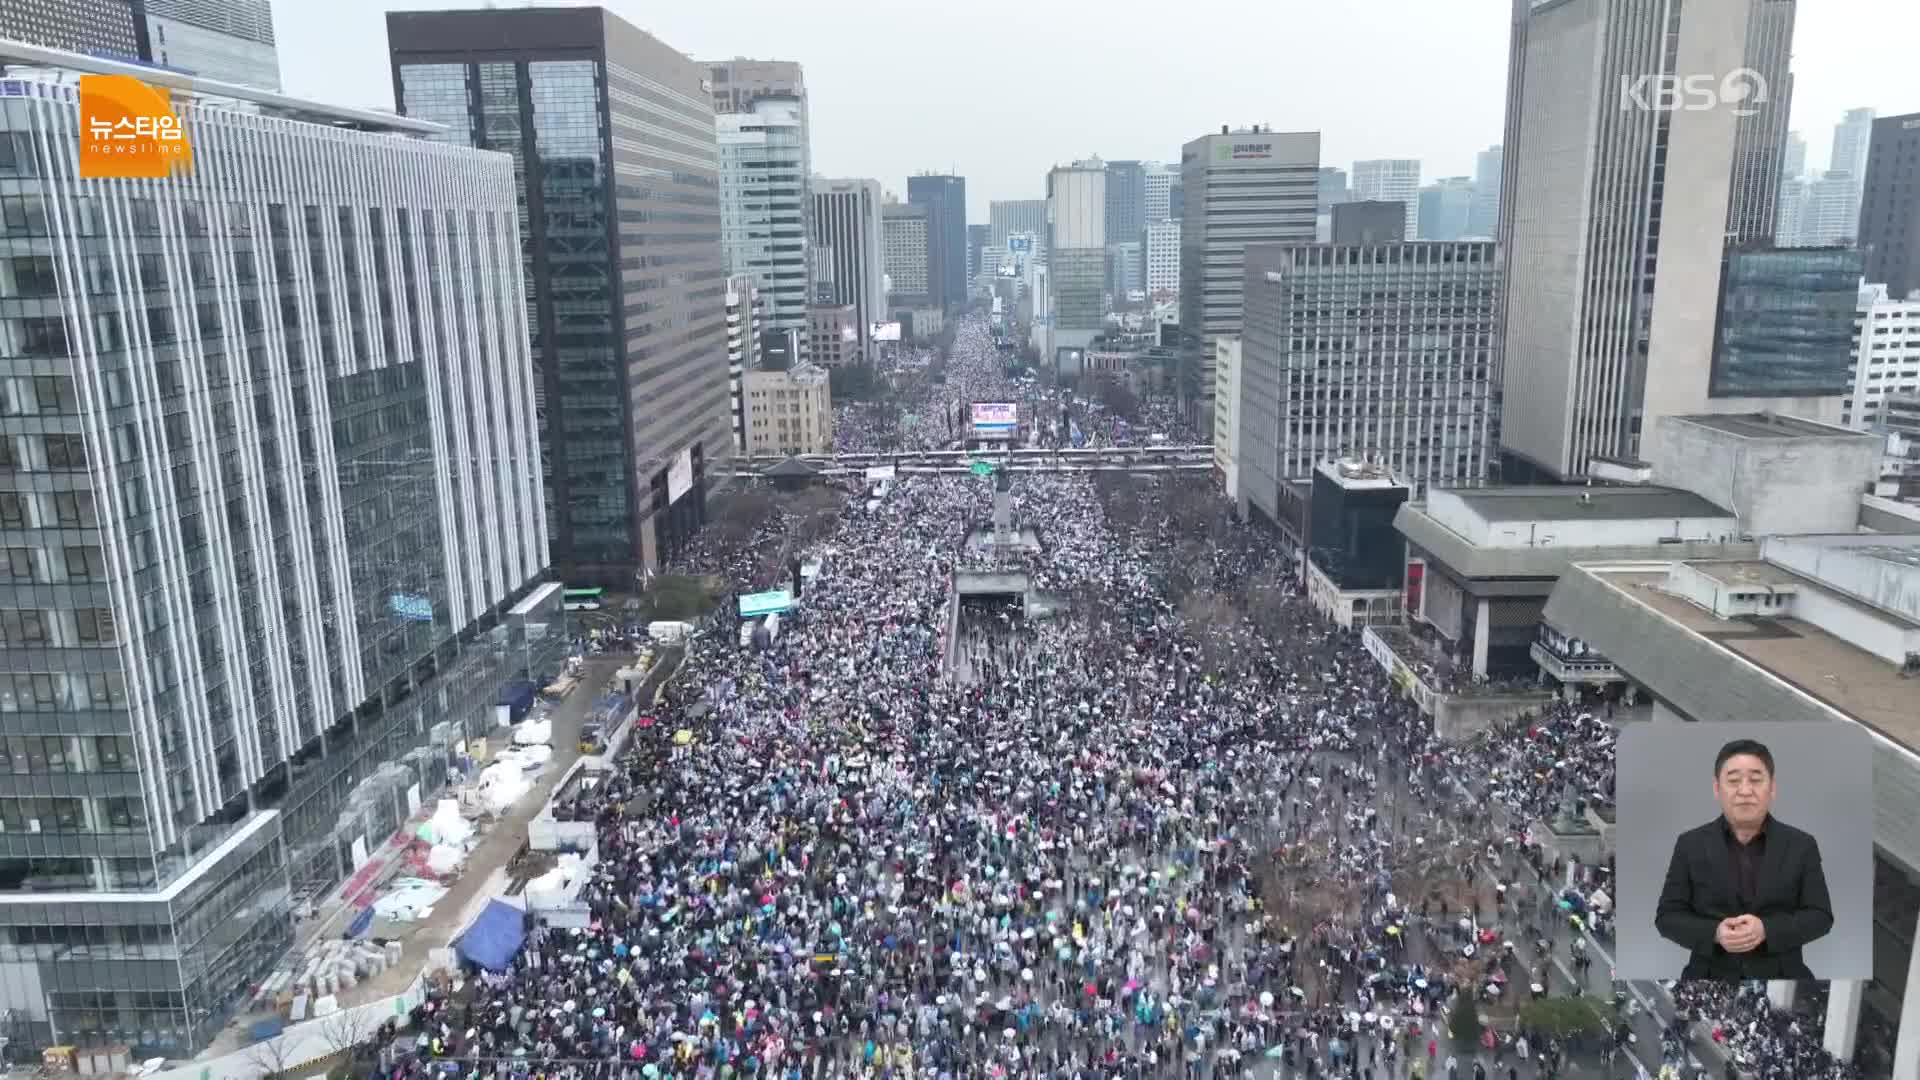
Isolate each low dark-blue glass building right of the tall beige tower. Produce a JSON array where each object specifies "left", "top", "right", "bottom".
[{"left": 1707, "top": 248, "right": 1860, "bottom": 398}]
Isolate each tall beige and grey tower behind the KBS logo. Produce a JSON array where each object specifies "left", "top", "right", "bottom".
[{"left": 1500, "top": 0, "right": 1791, "bottom": 474}]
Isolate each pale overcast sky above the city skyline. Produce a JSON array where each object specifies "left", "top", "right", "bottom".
[{"left": 273, "top": 0, "right": 1920, "bottom": 221}]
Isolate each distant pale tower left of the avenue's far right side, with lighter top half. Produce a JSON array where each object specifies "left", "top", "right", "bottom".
[{"left": 1041, "top": 160, "right": 1108, "bottom": 353}]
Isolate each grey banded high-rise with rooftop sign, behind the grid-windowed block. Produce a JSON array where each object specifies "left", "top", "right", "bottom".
[{"left": 1179, "top": 127, "right": 1319, "bottom": 425}]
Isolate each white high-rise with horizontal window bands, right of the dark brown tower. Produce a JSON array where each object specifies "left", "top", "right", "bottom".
[{"left": 714, "top": 94, "right": 814, "bottom": 361}]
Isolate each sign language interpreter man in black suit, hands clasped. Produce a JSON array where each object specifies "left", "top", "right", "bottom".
[{"left": 1653, "top": 738, "right": 1834, "bottom": 980}]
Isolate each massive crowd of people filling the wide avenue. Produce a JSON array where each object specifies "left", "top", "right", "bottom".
[{"left": 366, "top": 319, "right": 1881, "bottom": 1080}]
